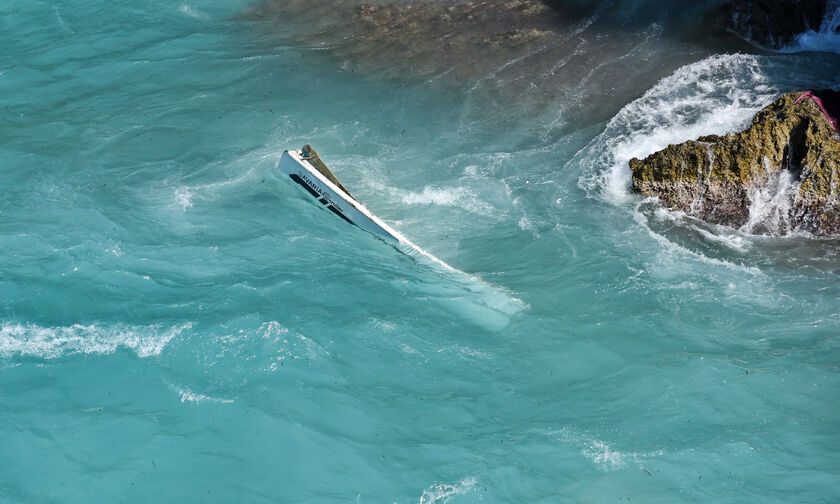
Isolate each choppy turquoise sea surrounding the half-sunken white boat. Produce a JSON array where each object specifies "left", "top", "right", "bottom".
[{"left": 0, "top": 0, "right": 840, "bottom": 504}]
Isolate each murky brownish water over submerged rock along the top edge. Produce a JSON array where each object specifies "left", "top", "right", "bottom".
[{"left": 240, "top": 0, "right": 728, "bottom": 130}]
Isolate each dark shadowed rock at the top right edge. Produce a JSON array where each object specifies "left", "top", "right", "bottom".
[{"left": 720, "top": 0, "right": 826, "bottom": 49}]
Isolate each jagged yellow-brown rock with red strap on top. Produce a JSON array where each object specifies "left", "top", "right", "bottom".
[{"left": 630, "top": 90, "right": 840, "bottom": 235}]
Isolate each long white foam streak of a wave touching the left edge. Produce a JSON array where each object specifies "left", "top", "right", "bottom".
[{"left": 0, "top": 322, "right": 192, "bottom": 359}]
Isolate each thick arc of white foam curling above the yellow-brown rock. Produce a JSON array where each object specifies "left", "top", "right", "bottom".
[{"left": 576, "top": 54, "right": 777, "bottom": 204}]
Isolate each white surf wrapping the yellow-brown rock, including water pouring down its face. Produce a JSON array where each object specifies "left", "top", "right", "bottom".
[{"left": 575, "top": 49, "right": 830, "bottom": 253}]
